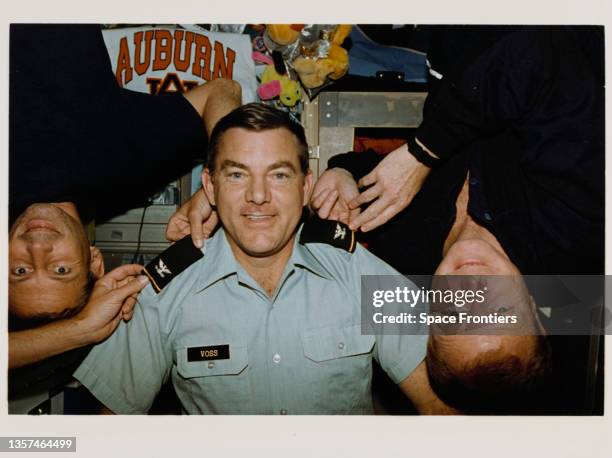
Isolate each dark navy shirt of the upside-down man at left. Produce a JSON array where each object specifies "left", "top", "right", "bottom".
[{"left": 9, "top": 24, "right": 206, "bottom": 222}]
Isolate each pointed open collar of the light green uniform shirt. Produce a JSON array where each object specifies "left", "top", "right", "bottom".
[{"left": 194, "top": 227, "right": 332, "bottom": 293}]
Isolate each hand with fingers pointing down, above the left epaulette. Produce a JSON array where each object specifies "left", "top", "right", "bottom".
[{"left": 166, "top": 189, "right": 219, "bottom": 248}]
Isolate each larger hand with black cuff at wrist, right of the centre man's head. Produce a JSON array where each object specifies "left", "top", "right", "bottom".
[{"left": 349, "top": 144, "right": 431, "bottom": 232}]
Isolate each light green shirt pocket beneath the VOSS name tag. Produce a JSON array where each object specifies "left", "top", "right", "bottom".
[{"left": 174, "top": 343, "right": 250, "bottom": 414}]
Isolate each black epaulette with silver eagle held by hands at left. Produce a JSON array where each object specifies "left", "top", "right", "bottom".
[{"left": 144, "top": 235, "right": 204, "bottom": 294}]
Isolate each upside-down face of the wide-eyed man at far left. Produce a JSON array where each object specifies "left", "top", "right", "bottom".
[{"left": 9, "top": 203, "right": 103, "bottom": 319}]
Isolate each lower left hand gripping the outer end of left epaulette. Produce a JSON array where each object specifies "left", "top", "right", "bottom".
[{"left": 72, "top": 264, "right": 149, "bottom": 343}]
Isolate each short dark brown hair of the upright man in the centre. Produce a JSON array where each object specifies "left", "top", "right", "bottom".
[{"left": 206, "top": 103, "right": 308, "bottom": 174}]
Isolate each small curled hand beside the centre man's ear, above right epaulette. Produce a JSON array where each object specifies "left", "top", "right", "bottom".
[{"left": 310, "top": 168, "right": 361, "bottom": 224}]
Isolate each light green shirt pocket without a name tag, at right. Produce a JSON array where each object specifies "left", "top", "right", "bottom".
[{"left": 301, "top": 324, "right": 375, "bottom": 414}]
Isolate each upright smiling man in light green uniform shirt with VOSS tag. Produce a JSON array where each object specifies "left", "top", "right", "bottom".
[{"left": 75, "top": 104, "right": 445, "bottom": 414}]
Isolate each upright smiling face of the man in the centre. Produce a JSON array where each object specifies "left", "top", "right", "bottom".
[{"left": 202, "top": 128, "right": 312, "bottom": 258}]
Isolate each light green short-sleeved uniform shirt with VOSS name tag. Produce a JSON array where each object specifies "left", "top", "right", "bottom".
[{"left": 74, "top": 230, "right": 427, "bottom": 414}]
